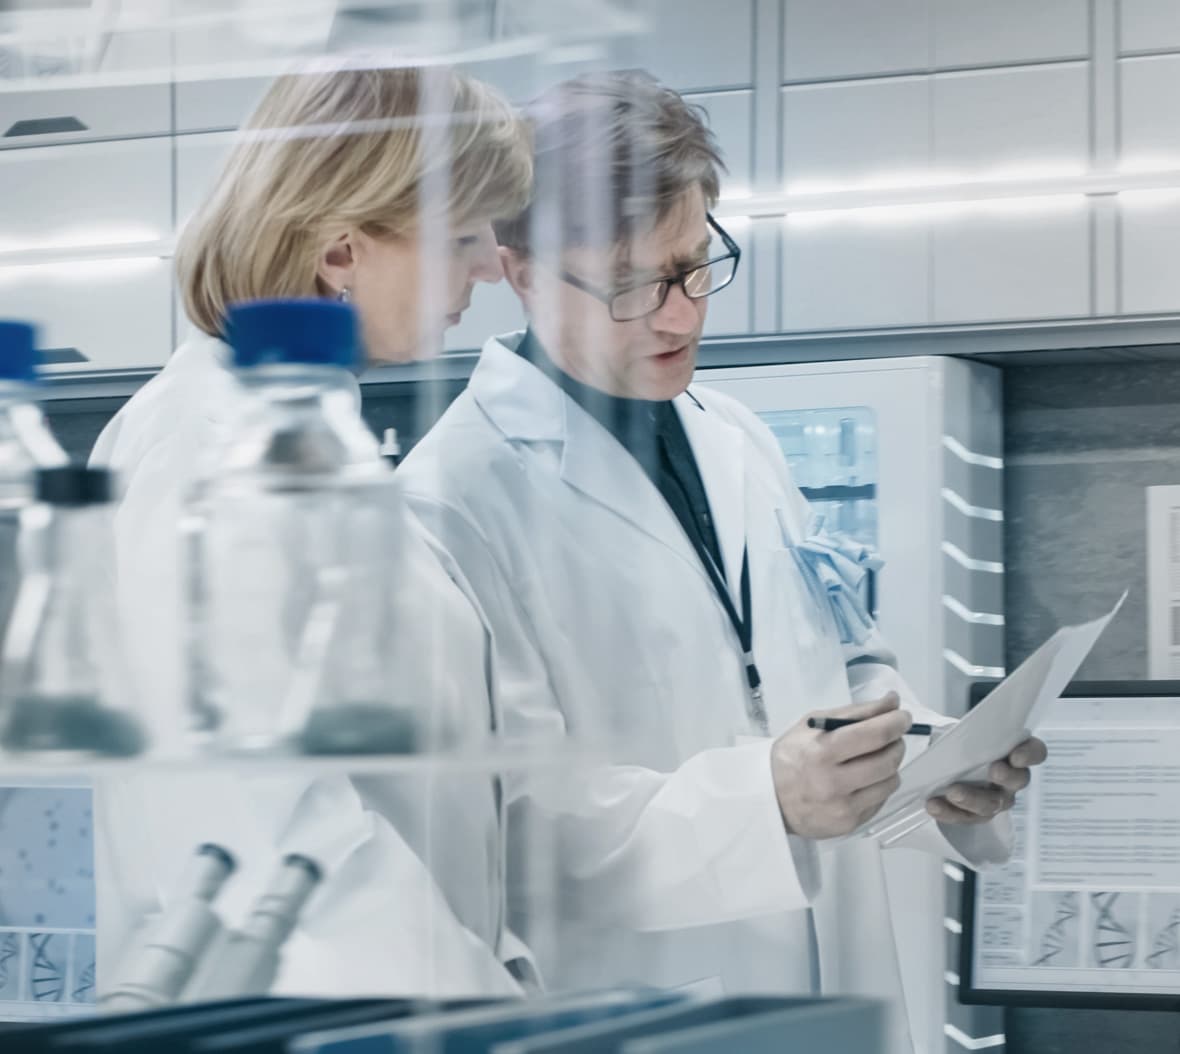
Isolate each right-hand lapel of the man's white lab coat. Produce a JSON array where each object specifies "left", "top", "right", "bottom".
[{"left": 675, "top": 393, "right": 746, "bottom": 615}]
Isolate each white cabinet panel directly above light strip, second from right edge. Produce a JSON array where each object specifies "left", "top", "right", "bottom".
[{"left": 933, "top": 63, "right": 1090, "bottom": 175}]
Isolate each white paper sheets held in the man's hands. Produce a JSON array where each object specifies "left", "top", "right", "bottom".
[{"left": 852, "top": 593, "right": 1127, "bottom": 845}]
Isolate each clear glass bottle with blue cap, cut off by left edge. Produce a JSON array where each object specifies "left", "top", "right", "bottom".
[{"left": 0, "top": 320, "right": 66, "bottom": 636}]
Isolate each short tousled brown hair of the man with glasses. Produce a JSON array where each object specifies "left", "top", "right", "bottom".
[{"left": 496, "top": 70, "right": 725, "bottom": 256}]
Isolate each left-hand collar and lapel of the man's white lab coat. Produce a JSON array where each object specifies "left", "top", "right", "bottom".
[{"left": 471, "top": 335, "right": 707, "bottom": 581}]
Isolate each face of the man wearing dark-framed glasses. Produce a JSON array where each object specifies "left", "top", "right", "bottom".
[{"left": 527, "top": 188, "right": 709, "bottom": 400}]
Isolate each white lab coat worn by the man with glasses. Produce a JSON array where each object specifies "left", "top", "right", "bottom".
[{"left": 399, "top": 336, "right": 1010, "bottom": 1050}]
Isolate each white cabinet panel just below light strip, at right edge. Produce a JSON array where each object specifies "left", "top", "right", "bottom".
[{"left": 1119, "top": 192, "right": 1180, "bottom": 315}]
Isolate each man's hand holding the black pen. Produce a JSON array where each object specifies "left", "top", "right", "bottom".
[{"left": 771, "top": 692, "right": 913, "bottom": 838}]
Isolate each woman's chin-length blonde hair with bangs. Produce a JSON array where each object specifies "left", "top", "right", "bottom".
[{"left": 176, "top": 66, "right": 532, "bottom": 336}]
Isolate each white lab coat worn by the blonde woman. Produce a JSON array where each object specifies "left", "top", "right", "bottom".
[{"left": 92, "top": 332, "right": 519, "bottom": 996}]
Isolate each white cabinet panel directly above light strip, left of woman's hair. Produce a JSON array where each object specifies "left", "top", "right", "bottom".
[{"left": 0, "top": 138, "right": 172, "bottom": 250}]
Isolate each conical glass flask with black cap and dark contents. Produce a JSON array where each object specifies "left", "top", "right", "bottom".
[{"left": 0, "top": 465, "right": 145, "bottom": 757}]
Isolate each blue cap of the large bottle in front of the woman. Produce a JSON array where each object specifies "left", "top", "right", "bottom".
[{"left": 225, "top": 300, "right": 360, "bottom": 369}]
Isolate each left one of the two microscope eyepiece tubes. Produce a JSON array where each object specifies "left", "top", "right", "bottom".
[{"left": 100, "top": 844, "right": 236, "bottom": 1010}]
